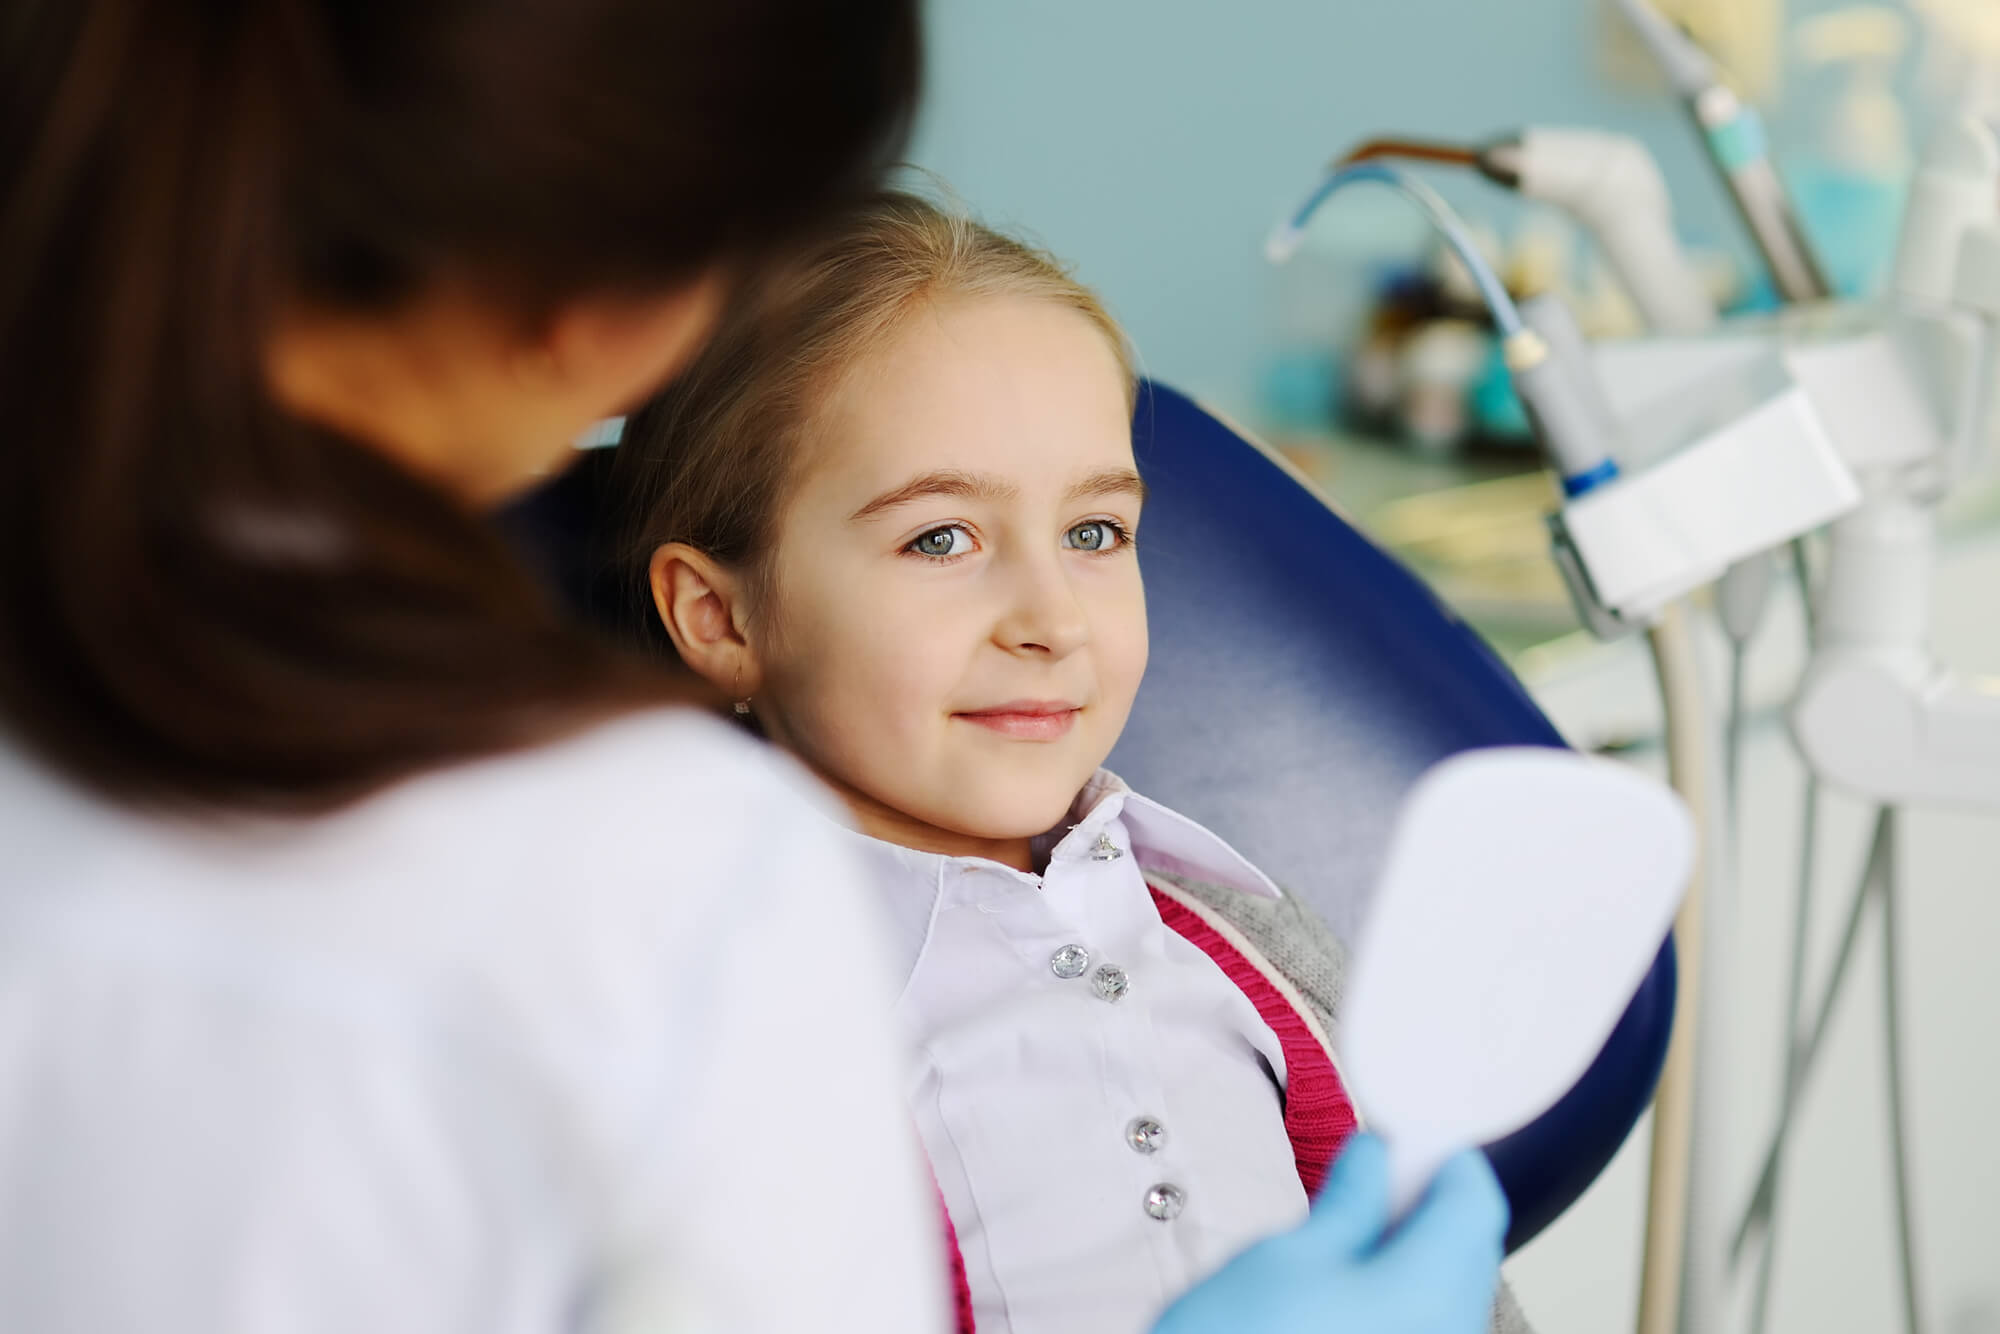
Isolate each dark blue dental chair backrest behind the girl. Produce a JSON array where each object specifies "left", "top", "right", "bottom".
[{"left": 502, "top": 382, "right": 1676, "bottom": 1250}]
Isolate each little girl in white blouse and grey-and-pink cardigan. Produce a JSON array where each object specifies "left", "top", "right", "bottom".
[{"left": 614, "top": 194, "right": 1512, "bottom": 1334}]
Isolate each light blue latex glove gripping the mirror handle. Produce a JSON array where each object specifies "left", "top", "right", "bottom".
[{"left": 1154, "top": 1134, "right": 1508, "bottom": 1334}]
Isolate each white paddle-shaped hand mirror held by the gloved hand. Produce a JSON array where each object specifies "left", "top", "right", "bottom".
[{"left": 1342, "top": 748, "right": 1694, "bottom": 1218}]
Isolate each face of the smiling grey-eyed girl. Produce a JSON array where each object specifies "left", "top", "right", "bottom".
[{"left": 750, "top": 296, "right": 1146, "bottom": 868}]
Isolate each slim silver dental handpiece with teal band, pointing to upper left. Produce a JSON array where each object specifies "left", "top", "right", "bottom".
[{"left": 1618, "top": 0, "right": 1834, "bottom": 302}]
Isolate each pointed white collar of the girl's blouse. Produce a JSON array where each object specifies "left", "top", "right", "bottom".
[{"left": 828, "top": 768, "right": 1284, "bottom": 992}]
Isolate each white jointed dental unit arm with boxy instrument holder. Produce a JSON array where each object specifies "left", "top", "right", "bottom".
[{"left": 1550, "top": 109, "right": 2000, "bottom": 806}]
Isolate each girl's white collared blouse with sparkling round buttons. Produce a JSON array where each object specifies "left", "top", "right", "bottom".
[{"left": 852, "top": 772, "right": 1306, "bottom": 1334}]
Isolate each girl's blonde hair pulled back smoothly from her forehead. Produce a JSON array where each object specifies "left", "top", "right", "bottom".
[{"left": 612, "top": 190, "right": 1136, "bottom": 630}]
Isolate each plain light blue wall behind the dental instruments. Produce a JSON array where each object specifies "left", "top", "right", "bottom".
[{"left": 914, "top": 0, "right": 1864, "bottom": 422}]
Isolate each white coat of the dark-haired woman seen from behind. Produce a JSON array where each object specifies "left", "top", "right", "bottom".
[{"left": 0, "top": 712, "right": 948, "bottom": 1334}]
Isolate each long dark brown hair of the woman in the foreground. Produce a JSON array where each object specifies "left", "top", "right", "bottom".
[{"left": 0, "top": 0, "right": 920, "bottom": 812}]
